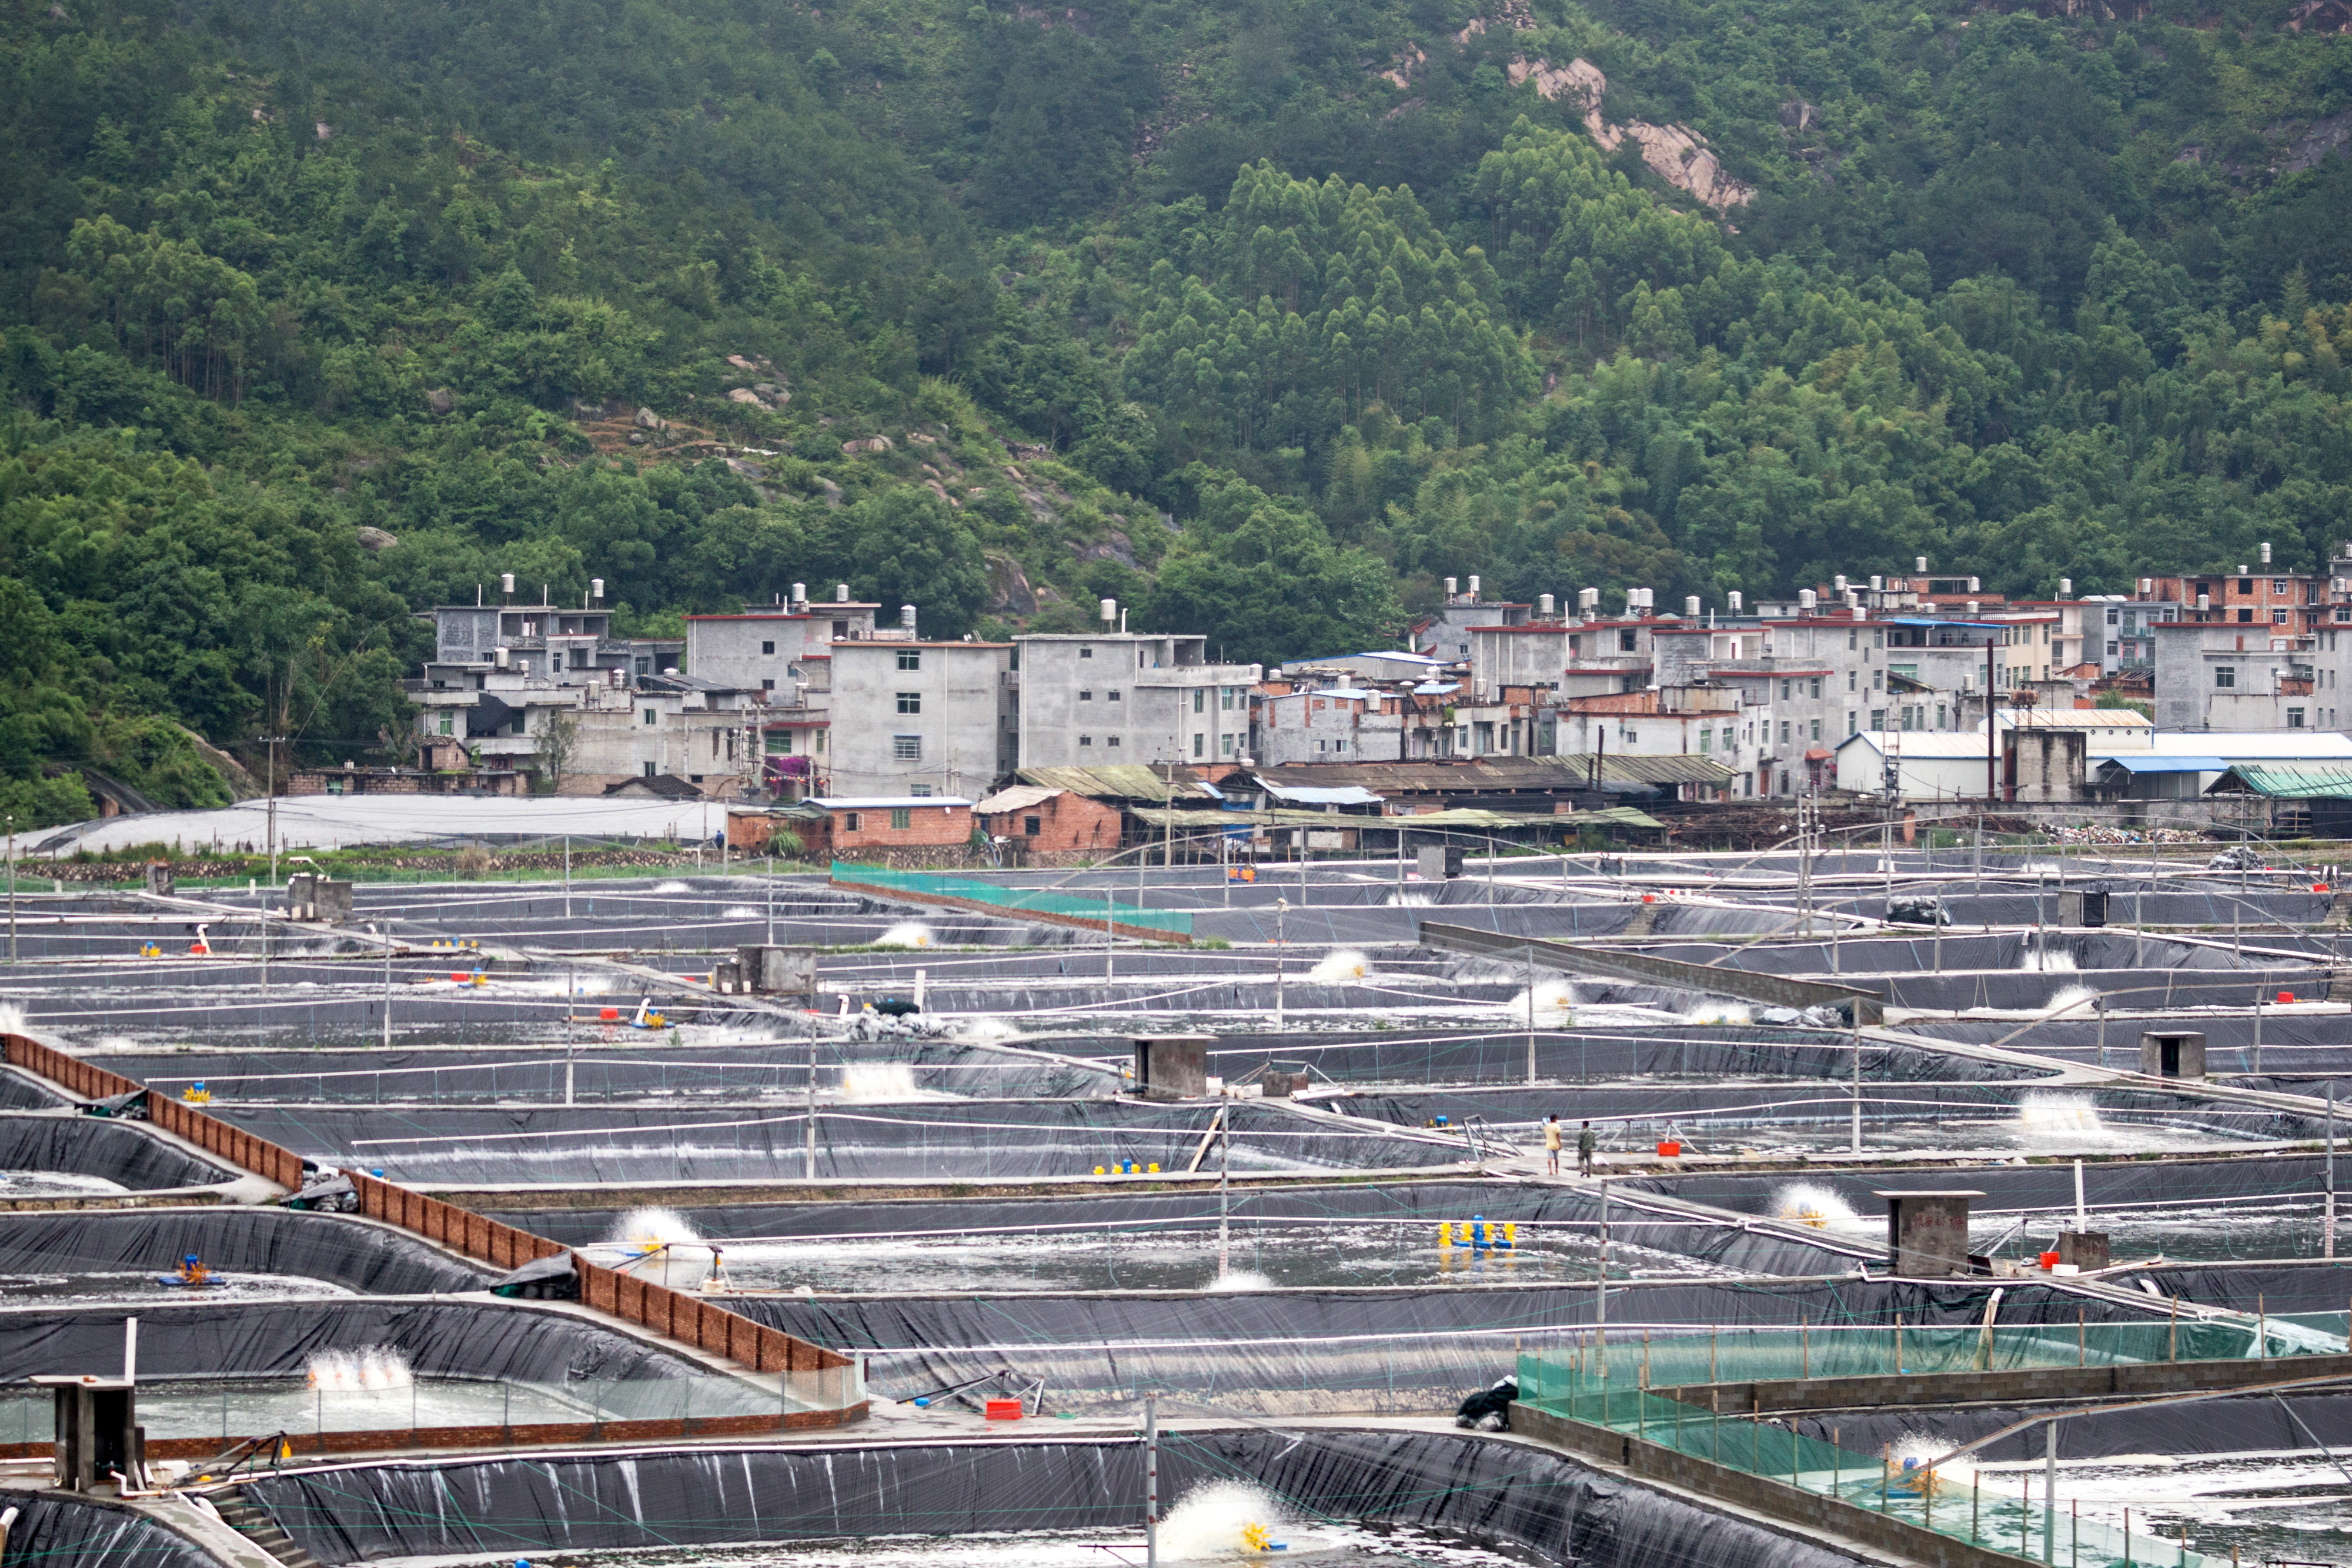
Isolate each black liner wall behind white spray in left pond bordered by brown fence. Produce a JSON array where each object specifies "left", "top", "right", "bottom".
[{"left": 0, "top": 1288, "right": 706, "bottom": 1382}]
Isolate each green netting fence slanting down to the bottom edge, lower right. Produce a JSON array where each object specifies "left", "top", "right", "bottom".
[{"left": 1519, "top": 1345, "right": 2211, "bottom": 1568}]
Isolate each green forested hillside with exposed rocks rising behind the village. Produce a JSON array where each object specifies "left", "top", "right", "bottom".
[{"left": 0, "top": 0, "right": 2352, "bottom": 827}]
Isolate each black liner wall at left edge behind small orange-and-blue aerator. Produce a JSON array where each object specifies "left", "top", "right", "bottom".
[{"left": 0, "top": 1208, "right": 492, "bottom": 1295}]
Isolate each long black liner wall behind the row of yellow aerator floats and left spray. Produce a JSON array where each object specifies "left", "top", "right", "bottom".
[{"left": 487, "top": 1180, "right": 1884, "bottom": 1276}]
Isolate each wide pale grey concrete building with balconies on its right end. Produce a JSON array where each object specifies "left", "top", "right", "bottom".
[{"left": 1016, "top": 625, "right": 1263, "bottom": 769}]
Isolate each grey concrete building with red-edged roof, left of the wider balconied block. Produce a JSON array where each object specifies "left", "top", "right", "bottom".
[{"left": 821, "top": 640, "right": 1016, "bottom": 797}]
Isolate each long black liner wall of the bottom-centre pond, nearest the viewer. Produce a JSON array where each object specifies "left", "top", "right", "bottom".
[{"left": 245, "top": 1429, "right": 1858, "bottom": 1568}]
